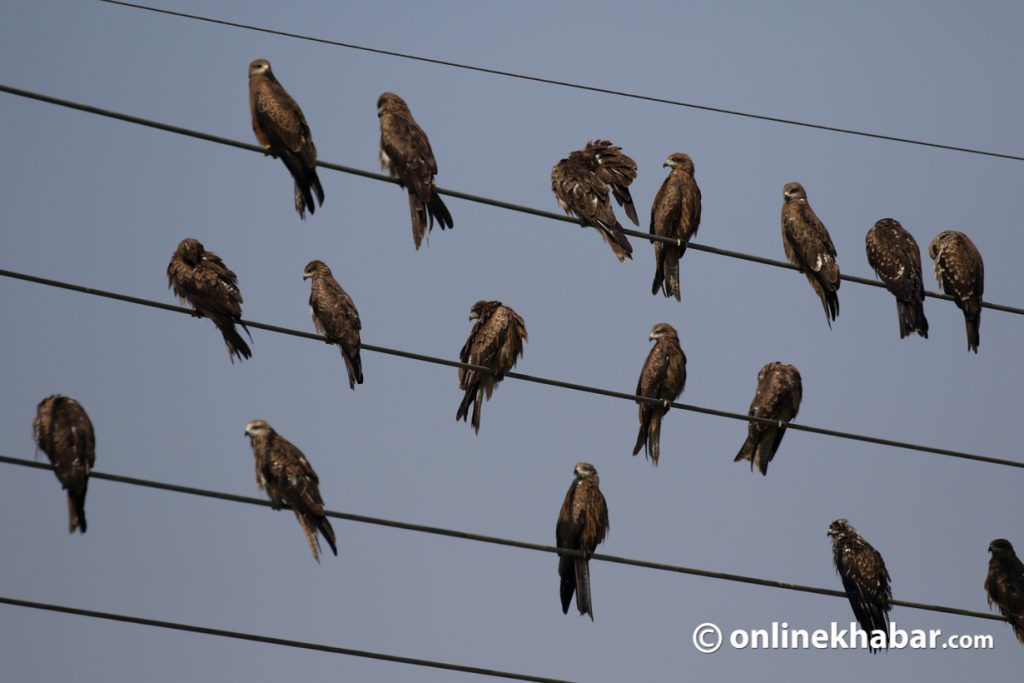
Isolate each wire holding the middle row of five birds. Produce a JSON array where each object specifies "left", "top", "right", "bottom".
[{"left": 0, "top": 268, "right": 1024, "bottom": 468}]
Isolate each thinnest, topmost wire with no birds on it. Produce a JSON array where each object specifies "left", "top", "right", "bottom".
[{"left": 99, "top": 0, "right": 1024, "bottom": 161}]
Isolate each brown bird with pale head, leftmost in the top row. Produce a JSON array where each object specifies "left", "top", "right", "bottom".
[{"left": 249, "top": 59, "right": 324, "bottom": 220}]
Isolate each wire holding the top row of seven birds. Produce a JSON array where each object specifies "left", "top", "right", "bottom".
[{"left": 0, "top": 81, "right": 1024, "bottom": 315}]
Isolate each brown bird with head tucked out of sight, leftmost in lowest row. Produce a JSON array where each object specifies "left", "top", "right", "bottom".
[{"left": 32, "top": 394, "right": 96, "bottom": 533}]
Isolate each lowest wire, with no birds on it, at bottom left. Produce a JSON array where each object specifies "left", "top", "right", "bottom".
[{"left": 0, "top": 596, "right": 570, "bottom": 683}]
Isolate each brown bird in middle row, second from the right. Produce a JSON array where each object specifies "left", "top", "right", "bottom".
[{"left": 633, "top": 323, "right": 686, "bottom": 466}]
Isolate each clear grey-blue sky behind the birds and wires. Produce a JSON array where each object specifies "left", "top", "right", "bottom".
[{"left": 0, "top": 0, "right": 1024, "bottom": 682}]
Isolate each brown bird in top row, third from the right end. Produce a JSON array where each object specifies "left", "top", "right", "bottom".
[{"left": 782, "top": 182, "right": 840, "bottom": 328}]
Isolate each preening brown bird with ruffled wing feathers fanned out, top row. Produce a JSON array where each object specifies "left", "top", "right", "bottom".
[{"left": 551, "top": 140, "right": 640, "bottom": 261}]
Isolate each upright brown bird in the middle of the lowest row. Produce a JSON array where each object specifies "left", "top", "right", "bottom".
[{"left": 555, "top": 463, "right": 608, "bottom": 622}]
